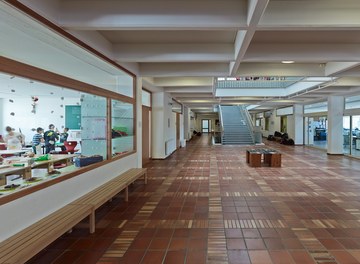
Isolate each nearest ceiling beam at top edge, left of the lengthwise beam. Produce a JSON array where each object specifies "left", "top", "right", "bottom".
[{"left": 58, "top": 0, "right": 247, "bottom": 30}]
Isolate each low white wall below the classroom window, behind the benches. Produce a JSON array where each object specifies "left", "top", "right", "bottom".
[{"left": 0, "top": 154, "right": 137, "bottom": 242}]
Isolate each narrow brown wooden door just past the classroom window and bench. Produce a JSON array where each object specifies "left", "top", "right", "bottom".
[{"left": 142, "top": 106, "right": 151, "bottom": 165}]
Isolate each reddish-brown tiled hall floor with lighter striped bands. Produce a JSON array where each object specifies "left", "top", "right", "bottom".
[{"left": 29, "top": 135, "right": 360, "bottom": 264}]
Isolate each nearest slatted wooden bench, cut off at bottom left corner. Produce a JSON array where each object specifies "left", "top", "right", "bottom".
[{"left": 0, "top": 204, "right": 92, "bottom": 264}]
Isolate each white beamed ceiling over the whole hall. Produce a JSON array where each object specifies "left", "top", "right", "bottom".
[{"left": 5, "top": 0, "right": 360, "bottom": 112}]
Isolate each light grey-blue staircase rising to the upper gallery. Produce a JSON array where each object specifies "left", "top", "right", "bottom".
[{"left": 220, "top": 105, "right": 254, "bottom": 145}]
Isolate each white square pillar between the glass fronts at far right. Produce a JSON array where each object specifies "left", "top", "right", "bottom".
[{"left": 327, "top": 96, "right": 344, "bottom": 154}]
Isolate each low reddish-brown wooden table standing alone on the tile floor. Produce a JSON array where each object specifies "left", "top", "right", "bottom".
[{"left": 246, "top": 148, "right": 281, "bottom": 167}]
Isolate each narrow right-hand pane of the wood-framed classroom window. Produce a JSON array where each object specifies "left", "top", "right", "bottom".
[{"left": 111, "top": 99, "right": 135, "bottom": 156}]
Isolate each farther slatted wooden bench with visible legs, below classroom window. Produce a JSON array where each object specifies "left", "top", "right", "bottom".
[{"left": 71, "top": 168, "right": 147, "bottom": 233}]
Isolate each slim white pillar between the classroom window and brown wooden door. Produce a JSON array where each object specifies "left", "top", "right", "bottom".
[{"left": 135, "top": 77, "right": 142, "bottom": 168}]
